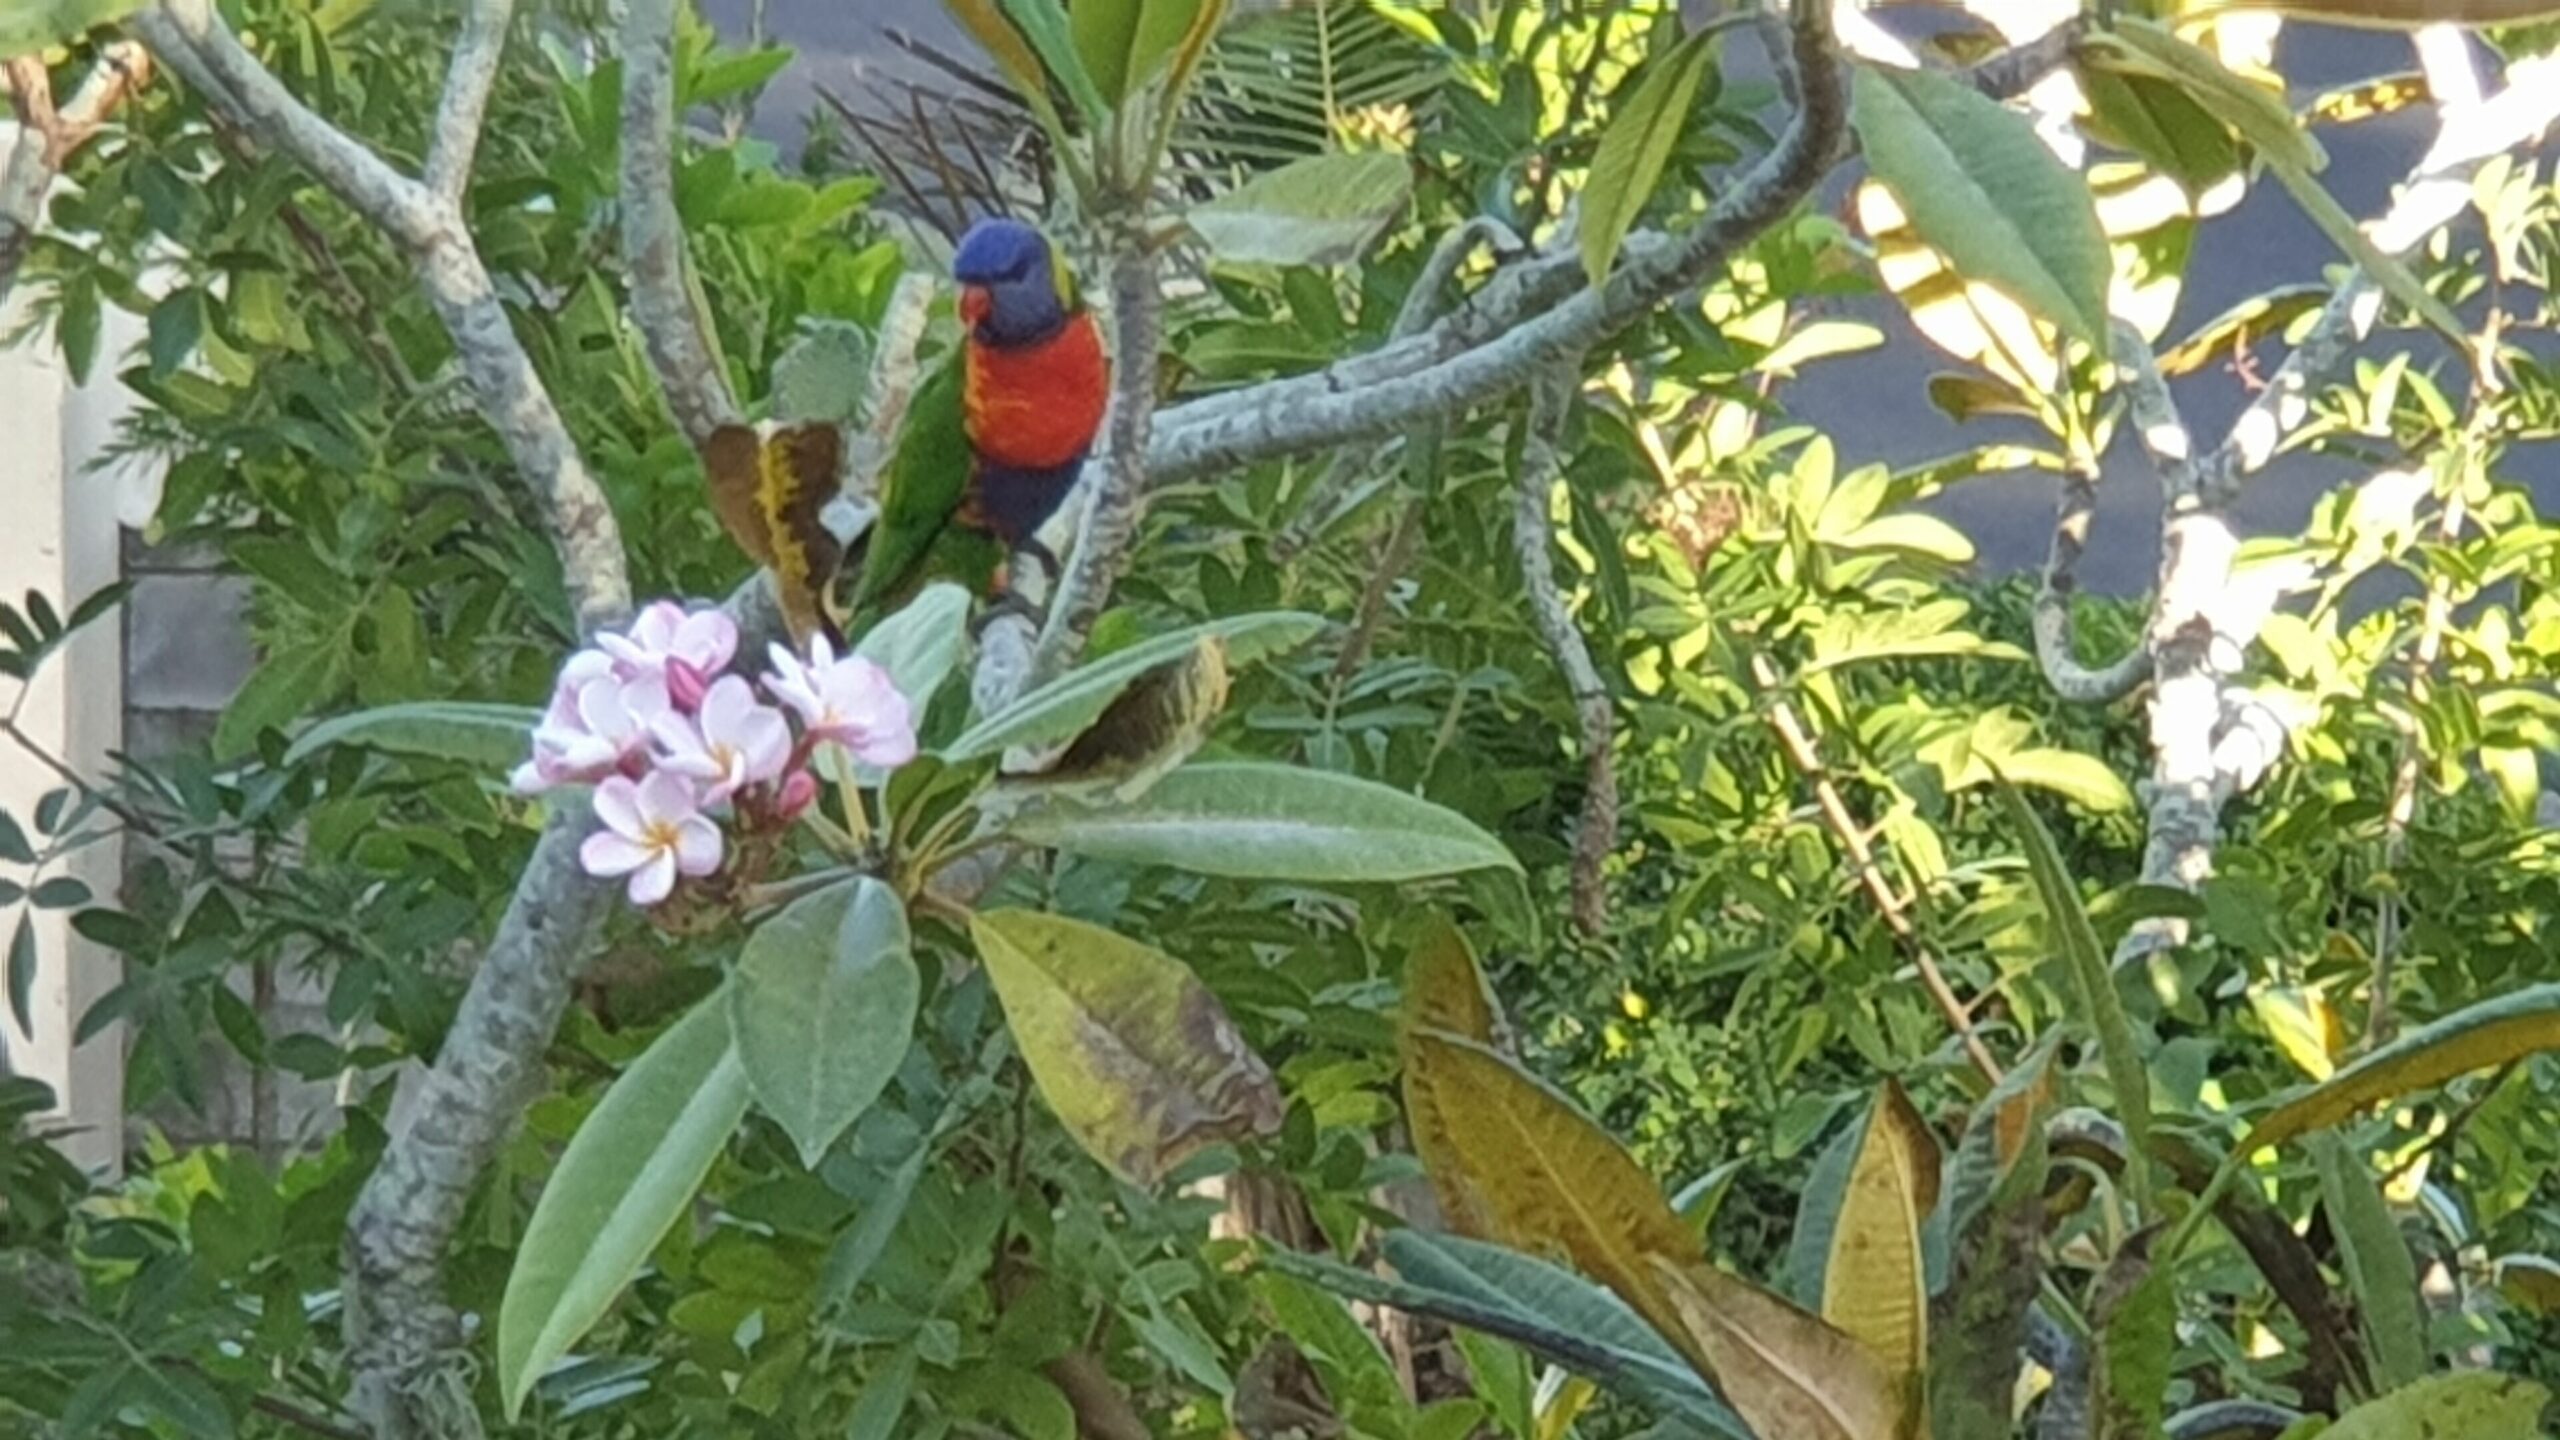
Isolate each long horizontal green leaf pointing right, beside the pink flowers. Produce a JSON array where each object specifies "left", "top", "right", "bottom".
[{"left": 1009, "top": 761, "right": 1521, "bottom": 884}]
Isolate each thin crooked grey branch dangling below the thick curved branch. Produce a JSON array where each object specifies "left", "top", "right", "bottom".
[{"left": 1510, "top": 356, "right": 1618, "bottom": 935}]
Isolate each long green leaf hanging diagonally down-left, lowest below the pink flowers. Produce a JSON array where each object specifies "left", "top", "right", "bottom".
[{"left": 497, "top": 994, "right": 748, "bottom": 1420}]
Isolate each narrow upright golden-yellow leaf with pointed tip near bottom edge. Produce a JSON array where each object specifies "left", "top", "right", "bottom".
[{"left": 1823, "top": 1081, "right": 1938, "bottom": 1396}]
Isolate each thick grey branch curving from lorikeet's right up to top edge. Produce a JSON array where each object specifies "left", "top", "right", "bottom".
[{"left": 1147, "top": 5, "right": 1848, "bottom": 484}]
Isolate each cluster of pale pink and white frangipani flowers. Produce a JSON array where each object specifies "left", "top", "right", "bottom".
[{"left": 512, "top": 600, "right": 916, "bottom": 904}]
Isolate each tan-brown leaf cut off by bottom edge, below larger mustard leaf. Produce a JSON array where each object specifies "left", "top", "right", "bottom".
[{"left": 1654, "top": 1261, "right": 1910, "bottom": 1440}]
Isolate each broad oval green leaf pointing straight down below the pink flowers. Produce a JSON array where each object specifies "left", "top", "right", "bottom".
[{"left": 730, "top": 876, "right": 919, "bottom": 1168}]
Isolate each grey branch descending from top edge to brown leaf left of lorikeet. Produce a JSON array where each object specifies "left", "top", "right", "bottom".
[{"left": 622, "top": 0, "right": 737, "bottom": 446}]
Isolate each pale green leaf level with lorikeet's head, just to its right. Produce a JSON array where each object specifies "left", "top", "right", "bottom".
[{"left": 1185, "top": 151, "right": 1413, "bottom": 266}]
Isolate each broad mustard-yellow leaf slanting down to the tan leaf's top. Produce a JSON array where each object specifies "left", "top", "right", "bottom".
[{"left": 1403, "top": 1027, "right": 1697, "bottom": 1361}]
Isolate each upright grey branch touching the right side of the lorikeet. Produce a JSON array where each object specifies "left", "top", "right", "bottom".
[{"left": 1032, "top": 225, "right": 1165, "bottom": 679}]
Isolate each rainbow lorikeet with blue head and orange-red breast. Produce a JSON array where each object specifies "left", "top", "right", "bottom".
[{"left": 847, "top": 220, "right": 1111, "bottom": 628}]
